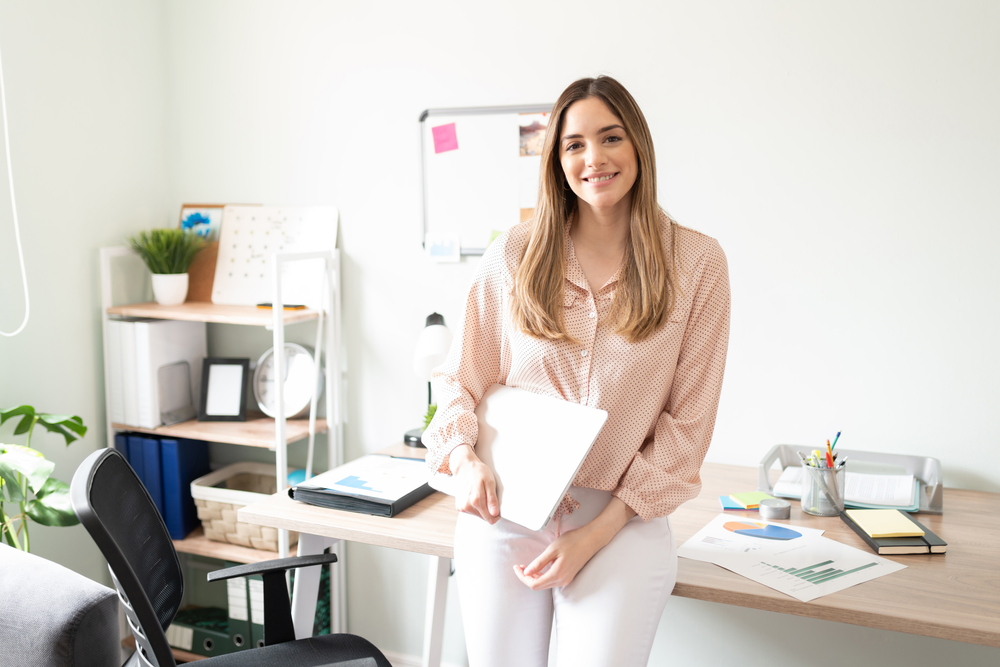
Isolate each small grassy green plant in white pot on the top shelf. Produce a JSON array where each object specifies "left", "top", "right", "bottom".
[{"left": 128, "top": 229, "right": 205, "bottom": 306}]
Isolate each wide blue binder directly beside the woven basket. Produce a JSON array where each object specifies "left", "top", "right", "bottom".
[{"left": 160, "top": 438, "right": 210, "bottom": 540}]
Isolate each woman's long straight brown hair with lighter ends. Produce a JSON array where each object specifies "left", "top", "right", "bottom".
[{"left": 511, "top": 76, "right": 680, "bottom": 342}]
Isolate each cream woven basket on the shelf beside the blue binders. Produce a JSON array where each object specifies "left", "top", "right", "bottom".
[{"left": 191, "top": 461, "right": 299, "bottom": 551}]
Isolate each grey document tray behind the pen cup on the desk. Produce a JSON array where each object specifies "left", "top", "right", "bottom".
[{"left": 757, "top": 445, "right": 944, "bottom": 514}]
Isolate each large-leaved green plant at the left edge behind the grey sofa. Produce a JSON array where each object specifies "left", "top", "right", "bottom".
[{"left": 0, "top": 405, "right": 87, "bottom": 551}]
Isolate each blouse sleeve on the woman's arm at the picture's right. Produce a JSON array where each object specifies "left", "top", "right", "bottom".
[{"left": 613, "top": 242, "right": 730, "bottom": 521}]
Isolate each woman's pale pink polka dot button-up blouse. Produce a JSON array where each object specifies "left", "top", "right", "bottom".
[{"left": 423, "top": 216, "right": 729, "bottom": 521}]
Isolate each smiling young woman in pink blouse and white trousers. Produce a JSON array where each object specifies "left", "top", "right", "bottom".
[{"left": 424, "top": 76, "right": 729, "bottom": 667}]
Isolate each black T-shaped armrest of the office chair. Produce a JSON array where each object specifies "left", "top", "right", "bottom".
[{"left": 208, "top": 554, "right": 337, "bottom": 646}]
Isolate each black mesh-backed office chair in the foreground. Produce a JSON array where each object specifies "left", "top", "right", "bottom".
[{"left": 70, "top": 449, "right": 391, "bottom": 667}]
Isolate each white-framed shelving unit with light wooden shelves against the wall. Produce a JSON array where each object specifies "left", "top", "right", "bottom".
[{"left": 100, "top": 246, "right": 346, "bottom": 640}]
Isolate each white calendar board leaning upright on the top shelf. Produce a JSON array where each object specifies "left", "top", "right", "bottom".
[{"left": 212, "top": 206, "right": 338, "bottom": 309}]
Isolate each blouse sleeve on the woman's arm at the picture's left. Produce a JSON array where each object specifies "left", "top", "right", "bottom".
[{"left": 422, "top": 234, "right": 508, "bottom": 474}]
